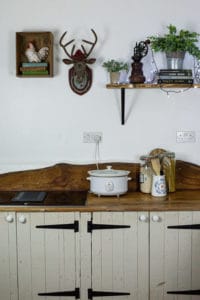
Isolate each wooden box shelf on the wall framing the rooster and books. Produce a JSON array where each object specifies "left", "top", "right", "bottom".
[{"left": 16, "top": 31, "right": 53, "bottom": 78}]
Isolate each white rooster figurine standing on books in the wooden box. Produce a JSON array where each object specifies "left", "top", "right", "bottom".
[{"left": 25, "top": 42, "right": 49, "bottom": 63}]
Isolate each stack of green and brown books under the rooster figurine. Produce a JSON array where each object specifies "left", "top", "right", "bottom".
[{"left": 20, "top": 62, "right": 49, "bottom": 75}]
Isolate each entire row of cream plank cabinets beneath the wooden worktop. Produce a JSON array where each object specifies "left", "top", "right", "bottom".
[{"left": 0, "top": 211, "right": 200, "bottom": 300}]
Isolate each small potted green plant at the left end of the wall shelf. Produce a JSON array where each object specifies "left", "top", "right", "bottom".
[{"left": 102, "top": 59, "right": 128, "bottom": 83}]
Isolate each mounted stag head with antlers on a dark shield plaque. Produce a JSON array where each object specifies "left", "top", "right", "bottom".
[{"left": 60, "top": 29, "right": 97, "bottom": 95}]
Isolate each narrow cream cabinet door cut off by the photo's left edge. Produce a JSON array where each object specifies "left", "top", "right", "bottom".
[{"left": 0, "top": 212, "right": 18, "bottom": 300}]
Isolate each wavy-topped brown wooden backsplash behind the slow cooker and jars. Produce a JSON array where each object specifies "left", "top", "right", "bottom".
[{"left": 0, "top": 160, "right": 200, "bottom": 192}]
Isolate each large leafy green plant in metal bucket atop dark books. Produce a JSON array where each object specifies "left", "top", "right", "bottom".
[{"left": 149, "top": 24, "right": 200, "bottom": 69}]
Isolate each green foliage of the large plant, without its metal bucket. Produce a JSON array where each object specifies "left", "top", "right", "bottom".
[{"left": 148, "top": 24, "right": 200, "bottom": 59}]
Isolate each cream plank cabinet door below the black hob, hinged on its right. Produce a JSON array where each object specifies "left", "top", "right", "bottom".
[{"left": 17, "top": 213, "right": 80, "bottom": 300}]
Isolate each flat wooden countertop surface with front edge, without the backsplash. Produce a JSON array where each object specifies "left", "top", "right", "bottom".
[{"left": 0, "top": 190, "right": 200, "bottom": 212}]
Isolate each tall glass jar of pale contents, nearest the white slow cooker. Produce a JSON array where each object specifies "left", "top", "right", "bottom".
[{"left": 140, "top": 155, "right": 153, "bottom": 194}]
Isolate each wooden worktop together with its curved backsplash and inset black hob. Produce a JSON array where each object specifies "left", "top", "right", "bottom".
[{"left": 0, "top": 161, "right": 200, "bottom": 212}]
